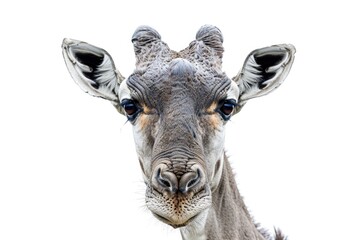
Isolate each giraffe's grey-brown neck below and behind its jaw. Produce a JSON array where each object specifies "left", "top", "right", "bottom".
[{"left": 181, "top": 157, "right": 264, "bottom": 240}]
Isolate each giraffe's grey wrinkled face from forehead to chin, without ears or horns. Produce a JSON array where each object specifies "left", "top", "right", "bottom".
[{"left": 119, "top": 58, "right": 239, "bottom": 227}]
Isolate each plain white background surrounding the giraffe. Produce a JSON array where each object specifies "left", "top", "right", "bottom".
[{"left": 0, "top": 0, "right": 360, "bottom": 240}]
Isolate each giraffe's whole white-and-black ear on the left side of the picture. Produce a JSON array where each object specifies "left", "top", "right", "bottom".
[{"left": 62, "top": 38, "right": 124, "bottom": 110}]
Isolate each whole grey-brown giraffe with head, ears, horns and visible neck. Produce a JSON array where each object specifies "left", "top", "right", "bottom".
[{"left": 62, "top": 25, "right": 295, "bottom": 240}]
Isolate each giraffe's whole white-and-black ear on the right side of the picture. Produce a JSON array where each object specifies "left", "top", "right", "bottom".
[{"left": 233, "top": 44, "right": 295, "bottom": 102}]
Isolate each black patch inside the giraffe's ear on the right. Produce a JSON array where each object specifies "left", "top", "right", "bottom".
[{"left": 254, "top": 52, "right": 287, "bottom": 89}]
